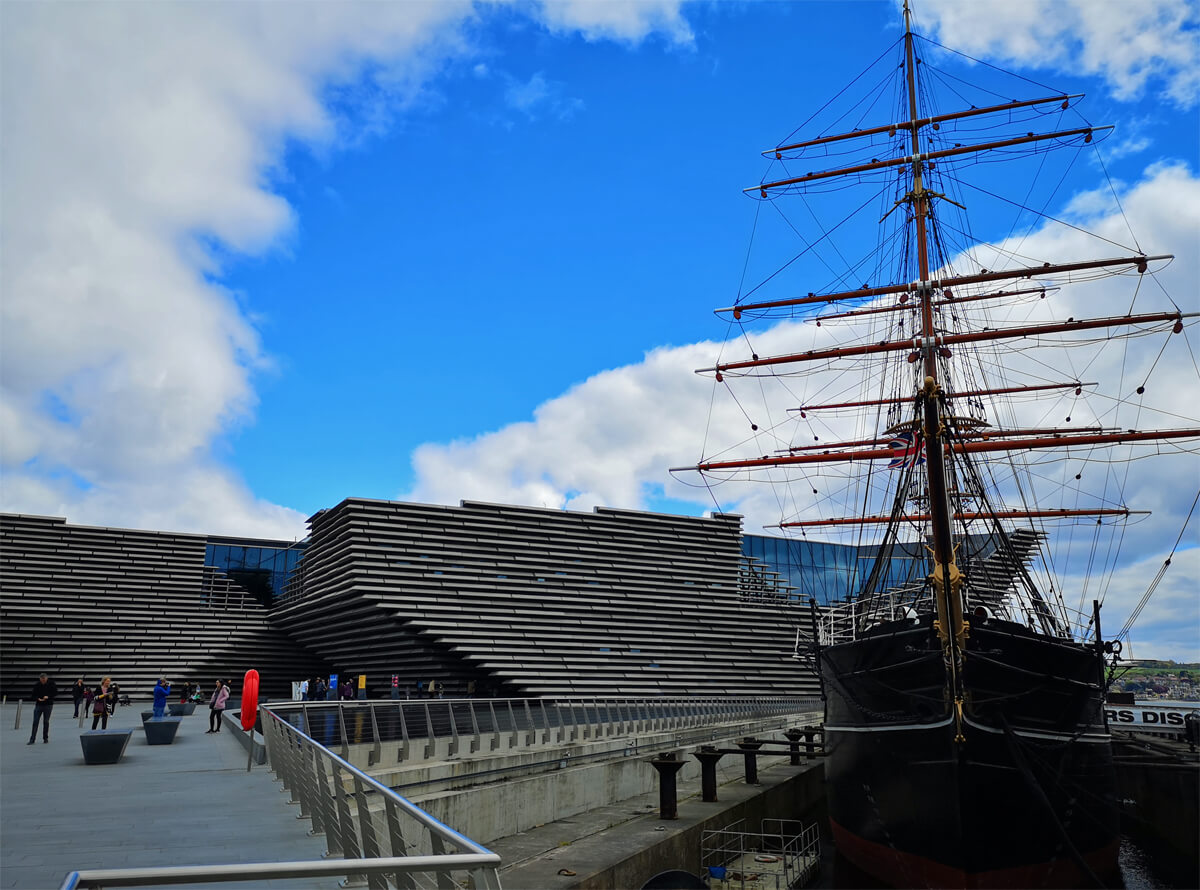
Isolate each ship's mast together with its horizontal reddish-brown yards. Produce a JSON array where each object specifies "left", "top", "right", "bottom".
[{"left": 672, "top": 0, "right": 1200, "bottom": 676}]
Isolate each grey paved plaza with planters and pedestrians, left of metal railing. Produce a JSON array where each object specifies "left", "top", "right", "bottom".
[{"left": 0, "top": 702, "right": 338, "bottom": 890}]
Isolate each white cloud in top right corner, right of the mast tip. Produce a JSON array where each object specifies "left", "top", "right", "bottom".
[{"left": 918, "top": 0, "right": 1200, "bottom": 107}]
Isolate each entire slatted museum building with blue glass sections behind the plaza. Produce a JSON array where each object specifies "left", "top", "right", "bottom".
[{"left": 0, "top": 498, "right": 883, "bottom": 698}]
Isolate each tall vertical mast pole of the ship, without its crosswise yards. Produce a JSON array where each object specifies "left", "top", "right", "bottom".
[{"left": 904, "top": 0, "right": 967, "bottom": 671}]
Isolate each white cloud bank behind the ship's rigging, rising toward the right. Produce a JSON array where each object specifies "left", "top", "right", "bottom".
[{"left": 403, "top": 164, "right": 1200, "bottom": 659}]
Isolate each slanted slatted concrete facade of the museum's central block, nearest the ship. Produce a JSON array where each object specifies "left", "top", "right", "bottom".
[{"left": 272, "top": 499, "right": 817, "bottom": 696}]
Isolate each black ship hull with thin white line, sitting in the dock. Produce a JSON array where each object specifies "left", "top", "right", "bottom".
[{"left": 821, "top": 617, "right": 1118, "bottom": 888}]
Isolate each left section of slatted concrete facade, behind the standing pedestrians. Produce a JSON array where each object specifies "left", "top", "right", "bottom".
[{"left": 0, "top": 515, "right": 325, "bottom": 698}]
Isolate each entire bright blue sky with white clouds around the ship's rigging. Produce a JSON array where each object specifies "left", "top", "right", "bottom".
[{"left": 7, "top": 0, "right": 1200, "bottom": 651}]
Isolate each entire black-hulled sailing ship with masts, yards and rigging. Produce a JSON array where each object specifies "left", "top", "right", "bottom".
[{"left": 686, "top": 2, "right": 1200, "bottom": 888}]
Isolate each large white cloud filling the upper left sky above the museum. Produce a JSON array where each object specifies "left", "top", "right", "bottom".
[{"left": 0, "top": 0, "right": 689, "bottom": 537}]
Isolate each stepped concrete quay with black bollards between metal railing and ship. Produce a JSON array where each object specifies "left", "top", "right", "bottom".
[{"left": 316, "top": 712, "right": 824, "bottom": 890}]
